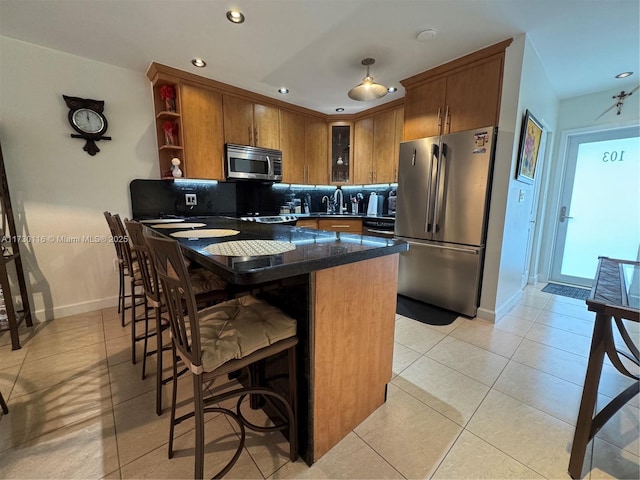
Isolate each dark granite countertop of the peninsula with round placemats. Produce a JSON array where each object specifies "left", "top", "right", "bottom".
[{"left": 147, "top": 215, "right": 408, "bottom": 285}]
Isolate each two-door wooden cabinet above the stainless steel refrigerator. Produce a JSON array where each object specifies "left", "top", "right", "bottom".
[{"left": 401, "top": 39, "right": 511, "bottom": 140}]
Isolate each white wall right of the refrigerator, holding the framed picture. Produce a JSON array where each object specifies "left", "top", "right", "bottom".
[{"left": 478, "top": 35, "right": 558, "bottom": 321}]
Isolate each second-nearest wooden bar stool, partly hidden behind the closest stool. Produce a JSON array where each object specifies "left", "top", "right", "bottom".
[{"left": 124, "top": 220, "right": 229, "bottom": 415}]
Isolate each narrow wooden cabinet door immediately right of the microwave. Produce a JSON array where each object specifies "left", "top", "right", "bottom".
[{"left": 280, "top": 110, "right": 307, "bottom": 183}]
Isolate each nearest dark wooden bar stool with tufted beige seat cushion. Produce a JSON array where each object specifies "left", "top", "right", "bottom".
[{"left": 147, "top": 237, "right": 298, "bottom": 478}]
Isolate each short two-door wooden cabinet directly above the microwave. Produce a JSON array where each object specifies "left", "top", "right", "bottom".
[{"left": 223, "top": 94, "right": 280, "bottom": 150}]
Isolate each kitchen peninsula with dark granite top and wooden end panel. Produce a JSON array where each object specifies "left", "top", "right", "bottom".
[{"left": 147, "top": 217, "right": 408, "bottom": 464}]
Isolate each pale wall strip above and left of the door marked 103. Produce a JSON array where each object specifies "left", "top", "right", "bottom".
[{"left": 538, "top": 83, "right": 640, "bottom": 280}]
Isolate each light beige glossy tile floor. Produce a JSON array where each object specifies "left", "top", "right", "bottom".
[{"left": 0, "top": 285, "right": 640, "bottom": 479}]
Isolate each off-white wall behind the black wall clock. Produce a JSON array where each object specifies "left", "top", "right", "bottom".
[{"left": 0, "top": 36, "right": 159, "bottom": 319}]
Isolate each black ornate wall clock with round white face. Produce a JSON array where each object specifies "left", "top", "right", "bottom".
[{"left": 62, "top": 95, "right": 111, "bottom": 156}]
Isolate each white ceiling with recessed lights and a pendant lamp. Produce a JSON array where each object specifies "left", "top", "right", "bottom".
[{"left": 0, "top": 0, "right": 640, "bottom": 114}]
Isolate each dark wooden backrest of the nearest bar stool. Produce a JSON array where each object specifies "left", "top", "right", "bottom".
[{"left": 146, "top": 236, "right": 202, "bottom": 375}]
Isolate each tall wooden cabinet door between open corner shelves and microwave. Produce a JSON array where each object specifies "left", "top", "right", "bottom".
[{"left": 180, "top": 83, "right": 224, "bottom": 180}]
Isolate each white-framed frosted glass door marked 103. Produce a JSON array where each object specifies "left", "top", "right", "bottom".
[{"left": 551, "top": 126, "right": 640, "bottom": 286}]
